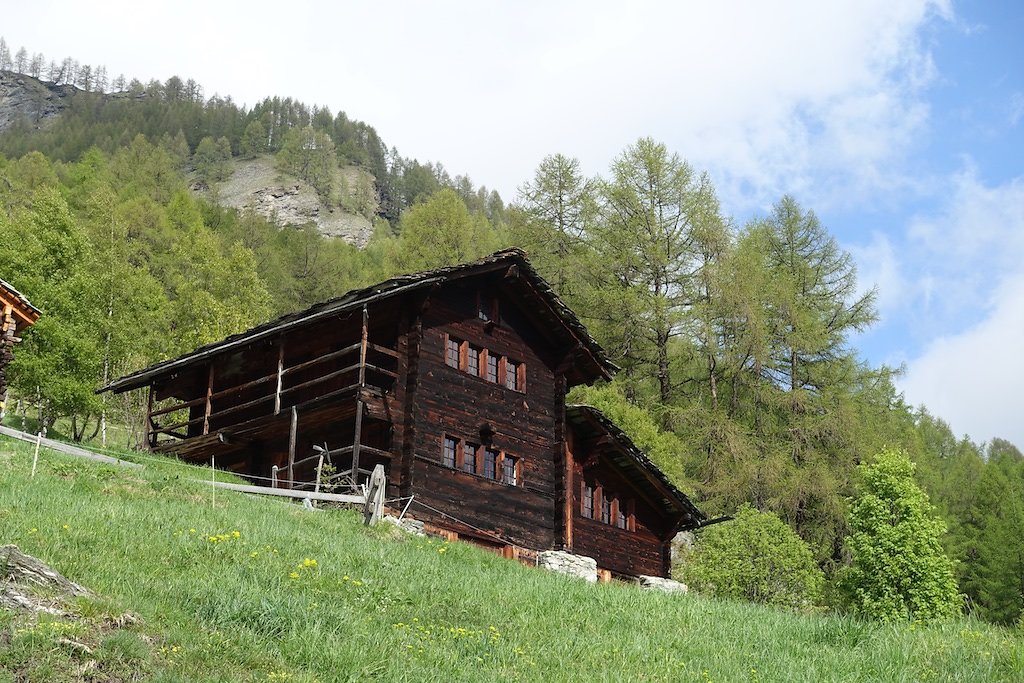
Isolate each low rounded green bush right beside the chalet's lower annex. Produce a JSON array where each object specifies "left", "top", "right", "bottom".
[{"left": 681, "top": 505, "right": 824, "bottom": 608}]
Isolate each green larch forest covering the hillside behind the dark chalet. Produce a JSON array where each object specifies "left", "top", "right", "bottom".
[{"left": 0, "top": 44, "right": 1024, "bottom": 624}]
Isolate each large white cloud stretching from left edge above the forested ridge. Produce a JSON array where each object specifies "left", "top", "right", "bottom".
[{"left": 3, "top": 0, "right": 952, "bottom": 206}]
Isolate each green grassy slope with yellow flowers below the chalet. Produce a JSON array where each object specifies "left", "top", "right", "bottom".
[{"left": 0, "top": 437, "right": 1024, "bottom": 682}]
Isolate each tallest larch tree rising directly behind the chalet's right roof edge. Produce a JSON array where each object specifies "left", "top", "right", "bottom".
[{"left": 593, "top": 138, "right": 721, "bottom": 404}]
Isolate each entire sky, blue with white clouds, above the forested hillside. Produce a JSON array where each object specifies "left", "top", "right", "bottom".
[{"left": 8, "top": 0, "right": 1024, "bottom": 447}]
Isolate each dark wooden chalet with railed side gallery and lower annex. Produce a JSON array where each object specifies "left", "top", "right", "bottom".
[{"left": 100, "top": 250, "right": 707, "bottom": 577}]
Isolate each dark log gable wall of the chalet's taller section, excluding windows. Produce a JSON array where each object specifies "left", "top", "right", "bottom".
[{"left": 410, "top": 286, "right": 564, "bottom": 549}]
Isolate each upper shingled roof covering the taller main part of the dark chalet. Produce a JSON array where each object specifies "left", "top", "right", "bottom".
[{"left": 97, "top": 248, "right": 618, "bottom": 393}]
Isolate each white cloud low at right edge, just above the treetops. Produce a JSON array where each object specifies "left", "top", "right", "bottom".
[{"left": 899, "top": 272, "right": 1024, "bottom": 446}]
